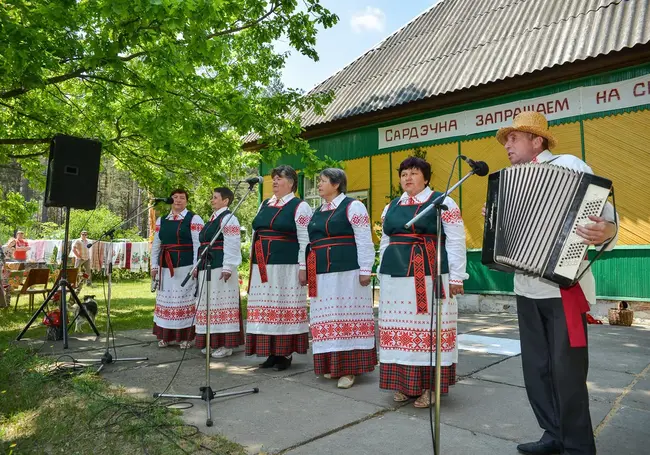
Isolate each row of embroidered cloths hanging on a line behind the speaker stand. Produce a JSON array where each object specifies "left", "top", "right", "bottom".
[{"left": 20, "top": 239, "right": 151, "bottom": 272}]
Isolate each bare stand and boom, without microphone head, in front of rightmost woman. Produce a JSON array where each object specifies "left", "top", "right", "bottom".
[{"left": 404, "top": 168, "right": 484, "bottom": 455}]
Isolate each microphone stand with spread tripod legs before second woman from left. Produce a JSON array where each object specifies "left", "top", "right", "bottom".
[{"left": 153, "top": 180, "right": 259, "bottom": 427}]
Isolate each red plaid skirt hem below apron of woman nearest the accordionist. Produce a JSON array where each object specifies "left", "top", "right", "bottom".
[{"left": 379, "top": 363, "right": 456, "bottom": 397}]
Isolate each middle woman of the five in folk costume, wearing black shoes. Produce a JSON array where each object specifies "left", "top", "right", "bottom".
[{"left": 246, "top": 165, "right": 312, "bottom": 371}]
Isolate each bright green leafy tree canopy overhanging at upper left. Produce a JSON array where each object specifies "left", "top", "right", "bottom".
[{"left": 0, "top": 0, "right": 338, "bottom": 190}]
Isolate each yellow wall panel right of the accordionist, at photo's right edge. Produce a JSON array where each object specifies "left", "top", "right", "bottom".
[{"left": 584, "top": 111, "right": 650, "bottom": 245}]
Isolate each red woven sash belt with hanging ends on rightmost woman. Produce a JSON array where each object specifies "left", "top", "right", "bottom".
[{"left": 390, "top": 234, "right": 445, "bottom": 314}]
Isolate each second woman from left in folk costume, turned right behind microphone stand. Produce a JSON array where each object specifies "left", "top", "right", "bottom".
[{"left": 196, "top": 187, "right": 244, "bottom": 358}]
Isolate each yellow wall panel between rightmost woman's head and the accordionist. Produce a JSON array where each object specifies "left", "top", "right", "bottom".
[{"left": 454, "top": 137, "right": 510, "bottom": 248}]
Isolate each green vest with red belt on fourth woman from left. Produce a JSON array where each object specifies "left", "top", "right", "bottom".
[{"left": 308, "top": 197, "right": 359, "bottom": 274}]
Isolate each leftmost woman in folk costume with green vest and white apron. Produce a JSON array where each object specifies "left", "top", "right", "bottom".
[{"left": 151, "top": 189, "right": 203, "bottom": 349}]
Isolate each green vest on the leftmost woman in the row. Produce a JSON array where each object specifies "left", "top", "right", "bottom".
[{"left": 158, "top": 210, "right": 194, "bottom": 268}]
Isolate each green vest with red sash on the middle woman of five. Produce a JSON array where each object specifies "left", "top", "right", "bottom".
[{"left": 252, "top": 197, "right": 302, "bottom": 264}]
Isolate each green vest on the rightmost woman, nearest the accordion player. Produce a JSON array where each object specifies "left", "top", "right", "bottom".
[{"left": 379, "top": 191, "right": 449, "bottom": 277}]
